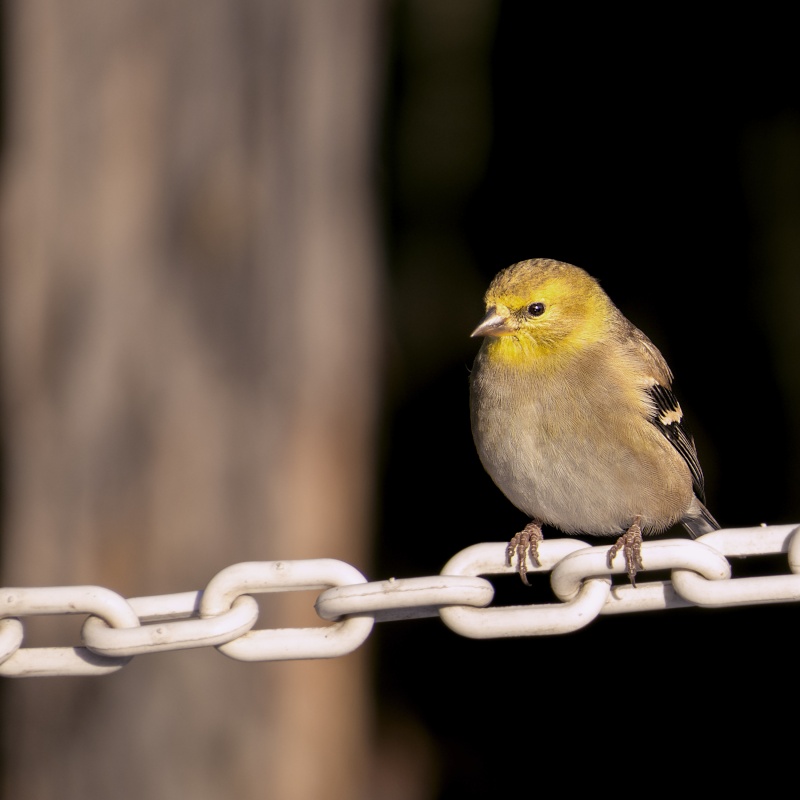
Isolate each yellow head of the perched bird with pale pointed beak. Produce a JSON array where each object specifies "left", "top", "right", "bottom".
[{"left": 472, "top": 258, "right": 619, "bottom": 363}]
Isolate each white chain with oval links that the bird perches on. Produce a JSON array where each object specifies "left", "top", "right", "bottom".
[{"left": 0, "top": 525, "right": 800, "bottom": 677}]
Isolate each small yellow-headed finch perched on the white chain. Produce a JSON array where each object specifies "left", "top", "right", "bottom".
[{"left": 469, "top": 258, "right": 720, "bottom": 587}]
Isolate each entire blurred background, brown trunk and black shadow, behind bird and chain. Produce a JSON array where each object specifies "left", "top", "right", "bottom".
[{"left": 0, "top": 0, "right": 800, "bottom": 800}]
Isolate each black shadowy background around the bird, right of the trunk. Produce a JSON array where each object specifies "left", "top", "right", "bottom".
[{"left": 376, "top": 2, "right": 800, "bottom": 798}]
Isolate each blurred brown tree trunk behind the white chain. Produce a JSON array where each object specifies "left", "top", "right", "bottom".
[{"left": 0, "top": 0, "right": 380, "bottom": 800}]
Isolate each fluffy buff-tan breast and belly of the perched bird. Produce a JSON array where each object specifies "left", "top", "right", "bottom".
[{"left": 470, "top": 348, "right": 691, "bottom": 534}]
